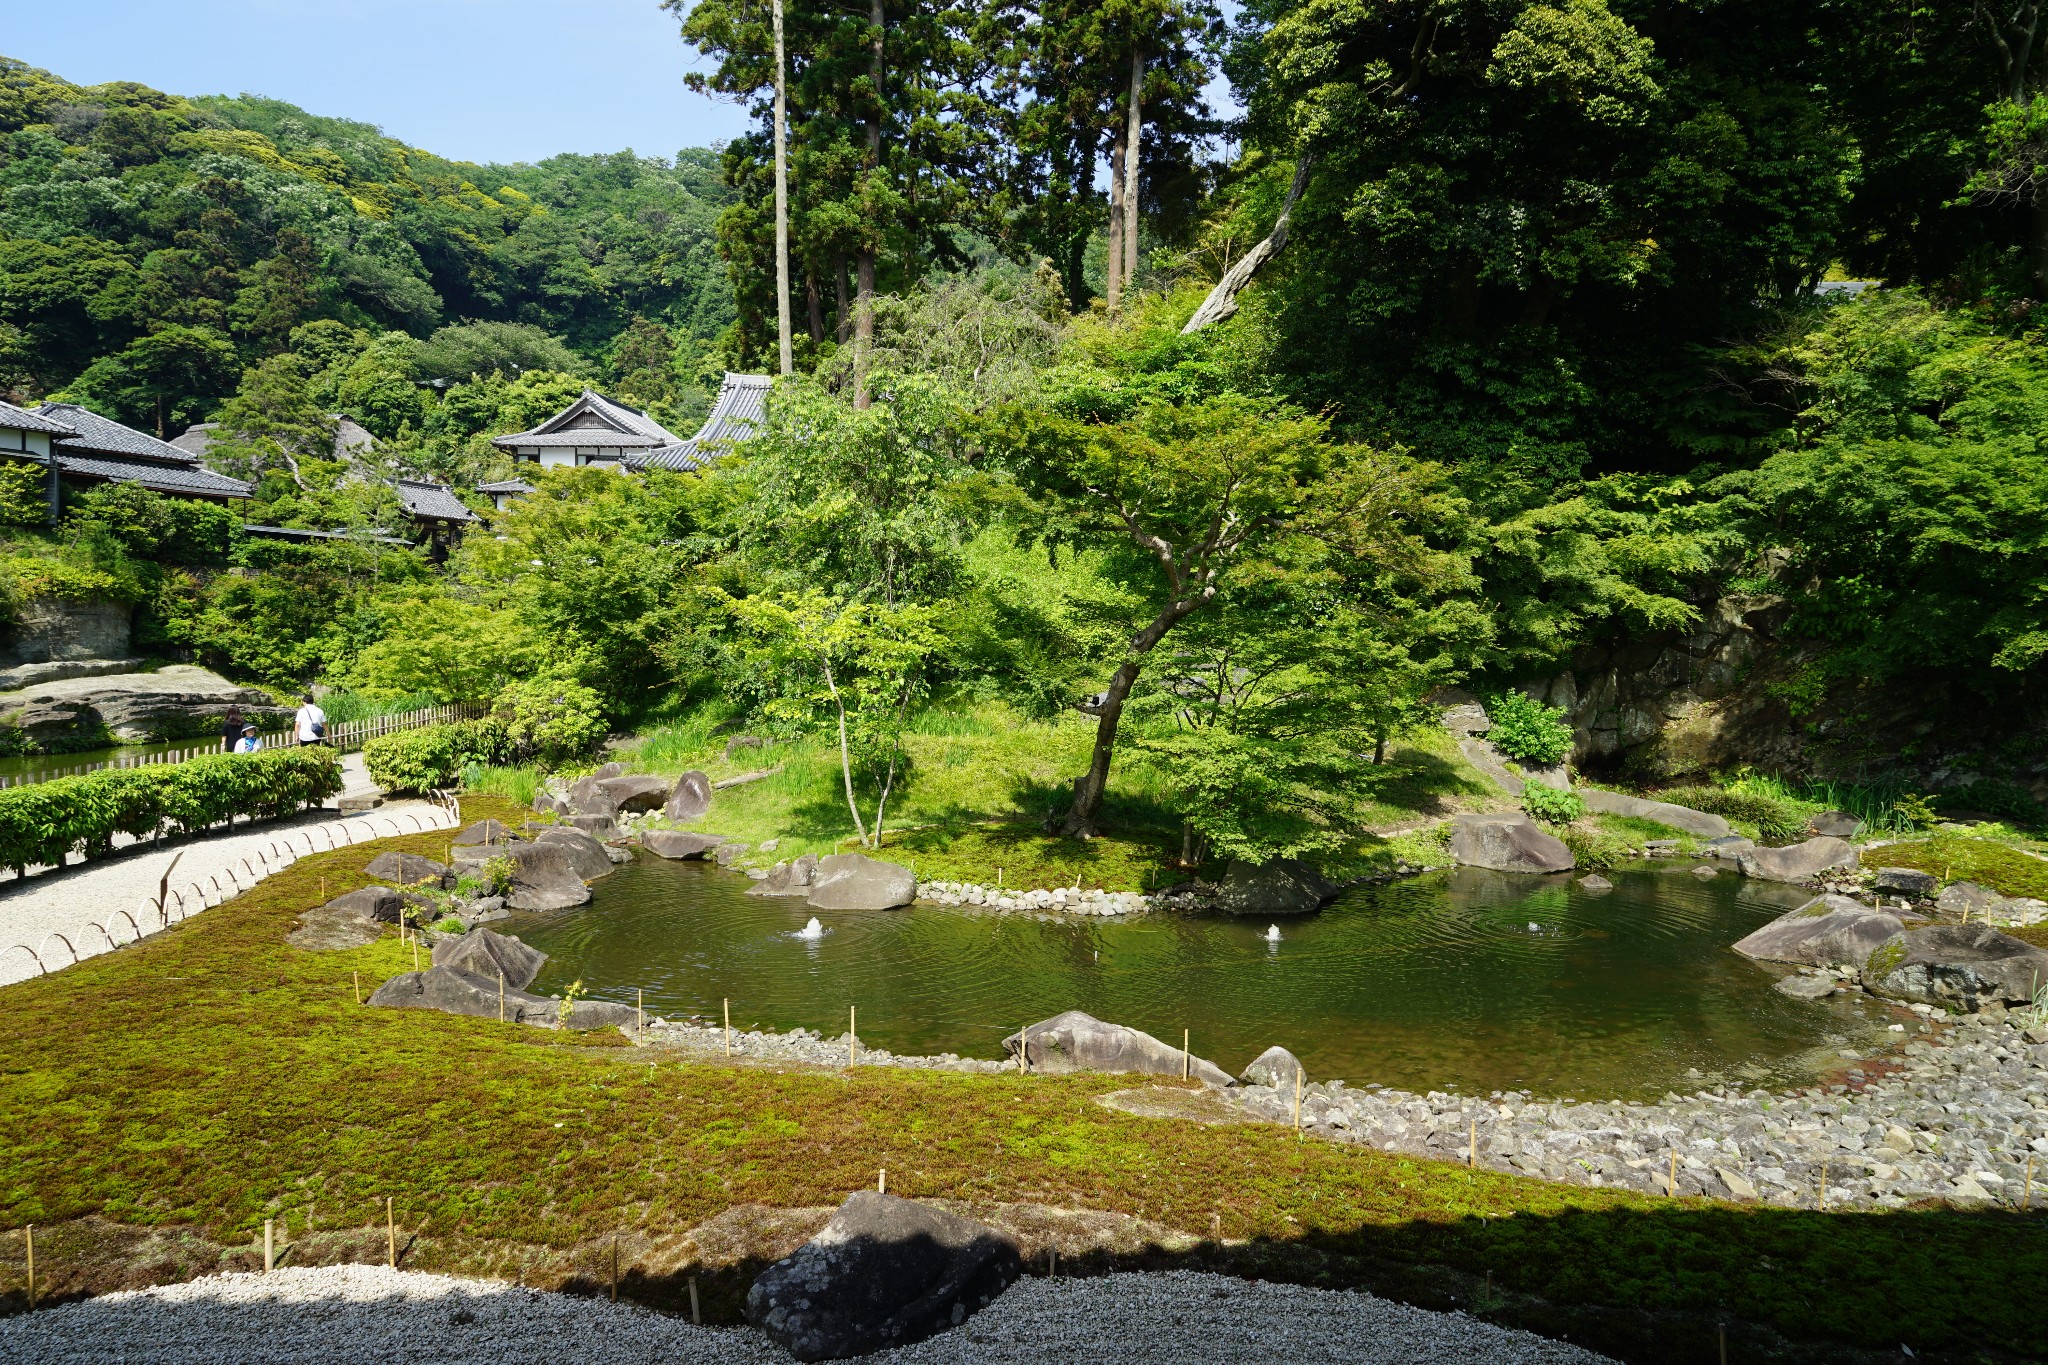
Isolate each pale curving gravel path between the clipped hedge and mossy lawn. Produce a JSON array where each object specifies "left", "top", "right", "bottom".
[{"left": 0, "top": 800, "right": 451, "bottom": 986}]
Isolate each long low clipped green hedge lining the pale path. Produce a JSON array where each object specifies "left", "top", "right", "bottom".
[{"left": 0, "top": 749, "right": 342, "bottom": 872}]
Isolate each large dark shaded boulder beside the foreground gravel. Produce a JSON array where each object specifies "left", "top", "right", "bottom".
[{"left": 748, "top": 1189, "right": 1024, "bottom": 1361}]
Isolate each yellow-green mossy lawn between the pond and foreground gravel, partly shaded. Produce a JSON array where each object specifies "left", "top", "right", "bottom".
[{"left": 0, "top": 798, "right": 2048, "bottom": 1359}]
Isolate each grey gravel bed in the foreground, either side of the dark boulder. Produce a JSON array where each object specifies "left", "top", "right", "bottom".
[{"left": 0, "top": 1265, "right": 1608, "bottom": 1365}]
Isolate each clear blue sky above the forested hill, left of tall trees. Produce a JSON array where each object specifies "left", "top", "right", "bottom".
[{"left": 0, "top": 0, "right": 745, "bottom": 162}]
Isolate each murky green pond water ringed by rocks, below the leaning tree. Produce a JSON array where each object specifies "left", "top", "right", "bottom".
[{"left": 500, "top": 857, "right": 1888, "bottom": 1097}]
